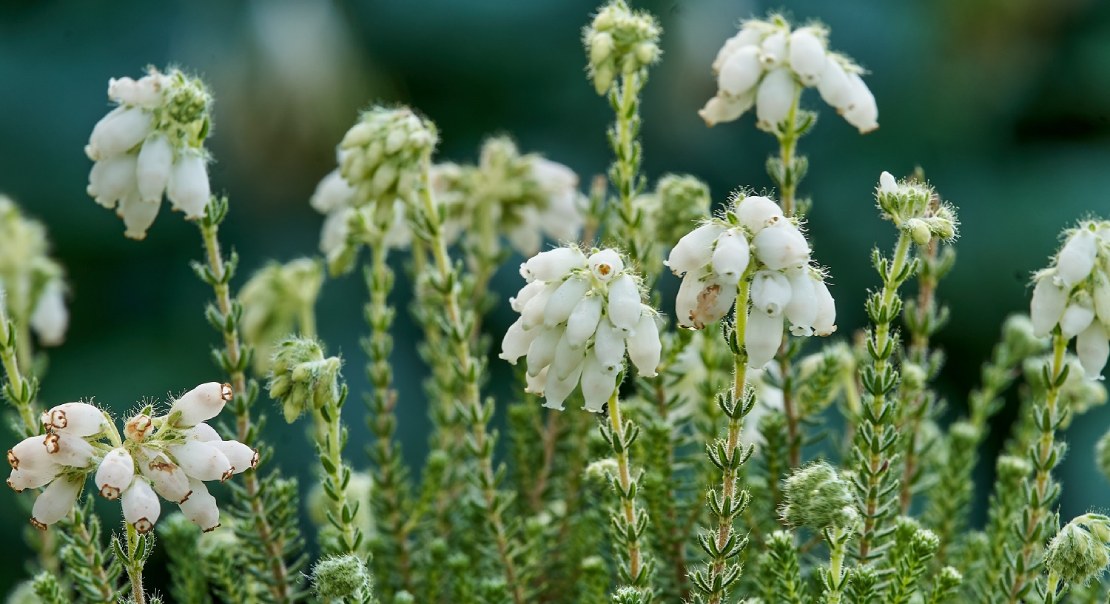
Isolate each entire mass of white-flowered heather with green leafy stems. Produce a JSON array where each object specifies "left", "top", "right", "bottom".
[{"left": 0, "top": 0, "right": 1110, "bottom": 604}]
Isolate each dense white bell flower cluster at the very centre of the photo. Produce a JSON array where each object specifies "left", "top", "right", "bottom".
[{"left": 501, "top": 246, "right": 662, "bottom": 412}]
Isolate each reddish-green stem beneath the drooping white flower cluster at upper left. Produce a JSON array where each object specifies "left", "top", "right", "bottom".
[{"left": 199, "top": 206, "right": 292, "bottom": 602}]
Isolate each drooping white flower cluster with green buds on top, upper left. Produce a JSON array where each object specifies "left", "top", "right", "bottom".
[{"left": 84, "top": 69, "right": 212, "bottom": 239}]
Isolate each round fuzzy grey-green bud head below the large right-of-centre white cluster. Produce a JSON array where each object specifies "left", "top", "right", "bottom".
[{"left": 779, "top": 462, "right": 859, "bottom": 531}]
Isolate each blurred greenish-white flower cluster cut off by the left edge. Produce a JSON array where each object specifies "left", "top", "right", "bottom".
[{"left": 0, "top": 195, "right": 69, "bottom": 346}]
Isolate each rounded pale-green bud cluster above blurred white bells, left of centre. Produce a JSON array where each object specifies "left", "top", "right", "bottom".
[{"left": 339, "top": 107, "right": 438, "bottom": 208}]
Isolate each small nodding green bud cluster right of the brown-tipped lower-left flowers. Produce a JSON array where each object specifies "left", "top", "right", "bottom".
[{"left": 269, "top": 338, "right": 343, "bottom": 423}]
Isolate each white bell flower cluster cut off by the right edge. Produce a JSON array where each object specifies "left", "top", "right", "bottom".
[{"left": 1030, "top": 220, "right": 1110, "bottom": 379}]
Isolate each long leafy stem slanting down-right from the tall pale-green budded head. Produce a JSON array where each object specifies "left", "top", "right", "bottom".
[{"left": 418, "top": 157, "right": 525, "bottom": 604}]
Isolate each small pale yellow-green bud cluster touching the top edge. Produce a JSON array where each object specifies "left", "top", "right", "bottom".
[{"left": 582, "top": 0, "right": 663, "bottom": 94}]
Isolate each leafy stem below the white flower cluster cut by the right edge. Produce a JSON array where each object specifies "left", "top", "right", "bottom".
[{"left": 1008, "top": 328, "right": 1068, "bottom": 604}]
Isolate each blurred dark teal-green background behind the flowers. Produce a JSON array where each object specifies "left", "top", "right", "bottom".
[{"left": 0, "top": 0, "right": 1110, "bottom": 593}]
